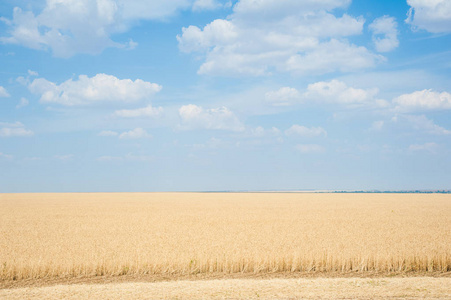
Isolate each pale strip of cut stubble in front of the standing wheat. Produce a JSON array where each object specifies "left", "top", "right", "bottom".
[{"left": 0, "top": 277, "right": 451, "bottom": 299}]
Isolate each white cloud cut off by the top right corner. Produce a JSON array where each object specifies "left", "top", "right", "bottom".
[{"left": 406, "top": 0, "right": 451, "bottom": 33}]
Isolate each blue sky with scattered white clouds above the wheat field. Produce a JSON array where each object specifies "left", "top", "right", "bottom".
[{"left": 0, "top": 0, "right": 451, "bottom": 192}]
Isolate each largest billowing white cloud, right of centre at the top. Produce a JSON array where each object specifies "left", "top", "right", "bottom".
[{"left": 177, "top": 0, "right": 383, "bottom": 76}]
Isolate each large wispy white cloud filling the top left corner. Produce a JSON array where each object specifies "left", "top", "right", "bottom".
[{"left": 0, "top": 0, "right": 191, "bottom": 57}]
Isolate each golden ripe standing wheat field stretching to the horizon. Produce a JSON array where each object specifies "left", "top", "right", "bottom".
[{"left": 0, "top": 193, "right": 451, "bottom": 283}]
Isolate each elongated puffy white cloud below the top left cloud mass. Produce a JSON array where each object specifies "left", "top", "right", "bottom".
[{"left": 28, "top": 74, "right": 162, "bottom": 106}]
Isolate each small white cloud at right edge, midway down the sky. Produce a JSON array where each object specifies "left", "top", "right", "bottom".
[{"left": 393, "top": 90, "right": 451, "bottom": 111}]
